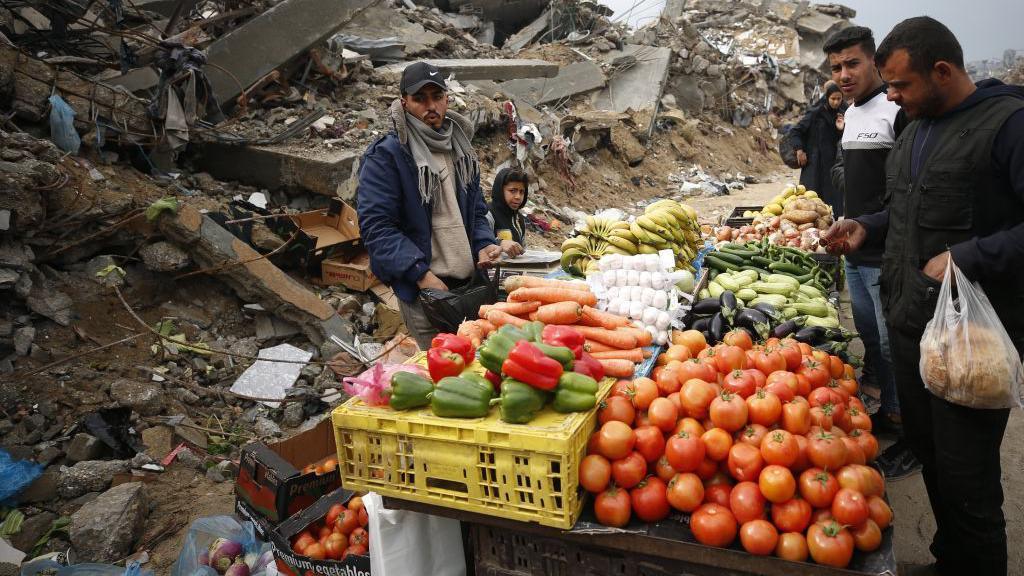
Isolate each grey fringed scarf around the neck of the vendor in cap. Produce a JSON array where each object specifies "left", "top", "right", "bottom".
[{"left": 390, "top": 99, "right": 480, "bottom": 205}]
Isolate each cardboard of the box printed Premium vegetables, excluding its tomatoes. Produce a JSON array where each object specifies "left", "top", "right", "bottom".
[{"left": 270, "top": 488, "right": 374, "bottom": 576}]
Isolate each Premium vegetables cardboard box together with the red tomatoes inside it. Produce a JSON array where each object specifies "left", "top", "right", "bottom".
[{"left": 270, "top": 488, "right": 371, "bottom": 576}]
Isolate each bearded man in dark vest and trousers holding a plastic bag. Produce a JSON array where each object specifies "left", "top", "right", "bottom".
[{"left": 824, "top": 16, "right": 1024, "bottom": 576}]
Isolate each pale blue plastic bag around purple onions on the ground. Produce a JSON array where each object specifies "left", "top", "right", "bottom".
[{"left": 171, "top": 516, "right": 273, "bottom": 576}]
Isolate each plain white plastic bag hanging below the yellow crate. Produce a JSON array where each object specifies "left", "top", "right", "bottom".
[{"left": 362, "top": 492, "right": 466, "bottom": 576}]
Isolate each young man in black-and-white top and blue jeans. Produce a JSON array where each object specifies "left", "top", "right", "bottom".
[{"left": 824, "top": 26, "right": 921, "bottom": 478}]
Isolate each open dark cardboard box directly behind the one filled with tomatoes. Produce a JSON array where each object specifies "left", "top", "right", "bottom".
[{"left": 234, "top": 418, "right": 341, "bottom": 526}]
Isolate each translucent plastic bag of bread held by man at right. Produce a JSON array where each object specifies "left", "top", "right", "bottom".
[{"left": 920, "top": 257, "right": 1024, "bottom": 409}]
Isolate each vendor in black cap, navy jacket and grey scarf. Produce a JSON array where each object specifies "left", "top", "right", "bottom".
[{"left": 357, "top": 61, "right": 502, "bottom": 348}]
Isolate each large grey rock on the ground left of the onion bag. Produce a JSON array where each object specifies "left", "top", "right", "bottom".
[{"left": 69, "top": 482, "right": 150, "bottom": 563}]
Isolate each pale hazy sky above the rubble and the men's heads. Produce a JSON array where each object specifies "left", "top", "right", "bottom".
[{"left": 601, "top": 0, "right": 1024, "bottom": 60}]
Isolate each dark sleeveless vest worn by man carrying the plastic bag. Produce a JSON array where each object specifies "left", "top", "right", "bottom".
[{"left": 881, "top": 97, "right": 1024, "bottom": 339}]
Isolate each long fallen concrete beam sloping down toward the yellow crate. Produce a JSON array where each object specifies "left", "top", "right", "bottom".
[{"left": 158, "top": 205, "right": 352, "bottom": 345}]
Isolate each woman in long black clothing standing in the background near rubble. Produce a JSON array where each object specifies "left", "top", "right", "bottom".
[{"left": 791, "top": 81, "right": 846, "bottom": 218}]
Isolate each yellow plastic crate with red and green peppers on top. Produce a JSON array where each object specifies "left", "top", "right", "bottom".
[{"left": 332, "top": 358, "right": 614, "bottom": 529}]
